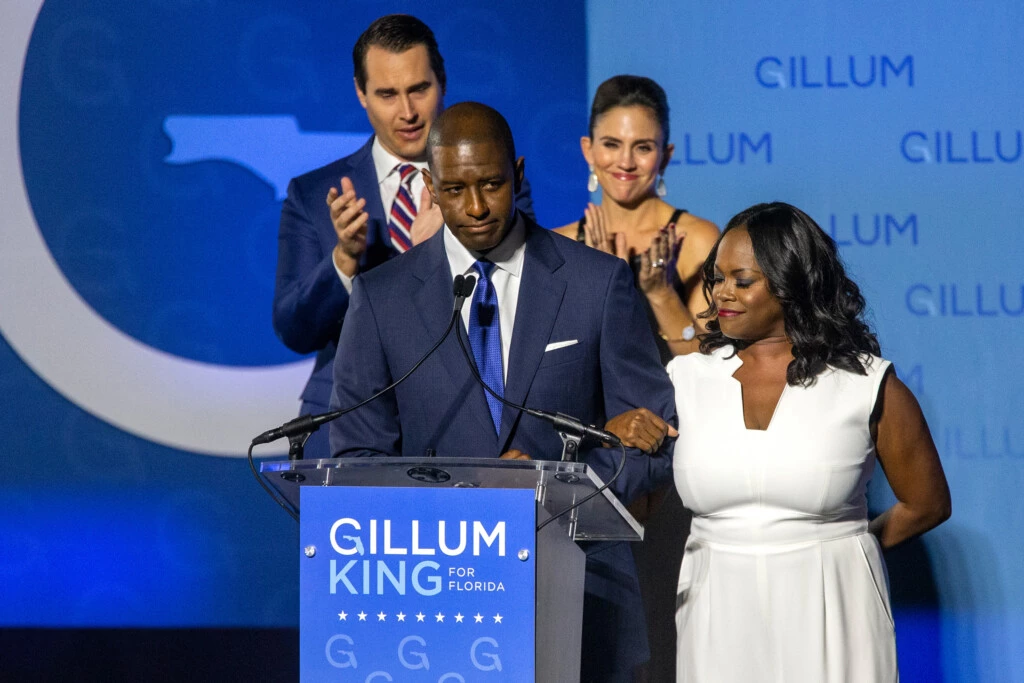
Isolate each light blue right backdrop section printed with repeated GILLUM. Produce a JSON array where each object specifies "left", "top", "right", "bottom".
[{"left": 587, "top": 0, "right": 1024, "bottom": 681}]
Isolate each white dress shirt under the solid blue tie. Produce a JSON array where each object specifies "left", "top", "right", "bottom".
[{"left": 441, "top": 211, "right": 526, "bottom": 383}]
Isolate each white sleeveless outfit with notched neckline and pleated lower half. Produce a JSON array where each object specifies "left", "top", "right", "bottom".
[{"left": 668, "top": 346, "right": 899, "bottom": 683}]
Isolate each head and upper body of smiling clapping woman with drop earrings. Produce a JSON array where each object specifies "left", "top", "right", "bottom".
[{"left": 556, "top": 76, "right": 718, "bottom": 362}]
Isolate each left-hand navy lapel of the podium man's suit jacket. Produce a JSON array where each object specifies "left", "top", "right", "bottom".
[{"left": 412, "top": 227, "right": 498, "bottom": 453}]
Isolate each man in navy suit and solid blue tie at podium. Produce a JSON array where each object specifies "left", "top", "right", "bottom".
[{"left": 330, "top": 102, "right": 675, "bottom": 681}]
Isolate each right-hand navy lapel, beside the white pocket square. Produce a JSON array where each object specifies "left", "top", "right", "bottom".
[{"left": 498, "top": 220, "right": 565, "bottom": 452}]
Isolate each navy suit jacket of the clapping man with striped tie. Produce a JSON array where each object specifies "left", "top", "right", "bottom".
[{"left": 273, "top": 136, "right": 532, "bottom": 458}]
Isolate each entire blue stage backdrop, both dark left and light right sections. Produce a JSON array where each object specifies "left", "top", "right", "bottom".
[{"left": 0, "top": 0, "right": 1024, "bottom": 681}]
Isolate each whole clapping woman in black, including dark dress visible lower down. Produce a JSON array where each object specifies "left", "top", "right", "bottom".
[{"left": 556, "top": 76, "right": 718, "bottom": 681}]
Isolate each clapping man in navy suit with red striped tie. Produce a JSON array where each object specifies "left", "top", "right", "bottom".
[{"left": 273, "top": 14, "right": 532, "bottom": 458}]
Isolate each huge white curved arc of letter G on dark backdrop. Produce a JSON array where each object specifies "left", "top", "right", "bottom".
[{"left": 0, "top": 0, "right": 312, "bottom": 457}]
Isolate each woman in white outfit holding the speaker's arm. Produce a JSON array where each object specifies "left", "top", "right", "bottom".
[{"left": 609, "top": 203, "right": 950, "bottom": 683}]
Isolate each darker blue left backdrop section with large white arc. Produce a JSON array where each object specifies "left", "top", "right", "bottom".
[{"left": 0, "top": 0, "right": 587, "bottom": 627}]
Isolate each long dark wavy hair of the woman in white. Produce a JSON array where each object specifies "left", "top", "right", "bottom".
[{"left": 700, "top": 202, "right": 881, "bottom": 386}]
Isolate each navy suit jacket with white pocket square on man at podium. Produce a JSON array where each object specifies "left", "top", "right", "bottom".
[{"left": 331, "top": 221, "right": 676, "bottom": 679}]
